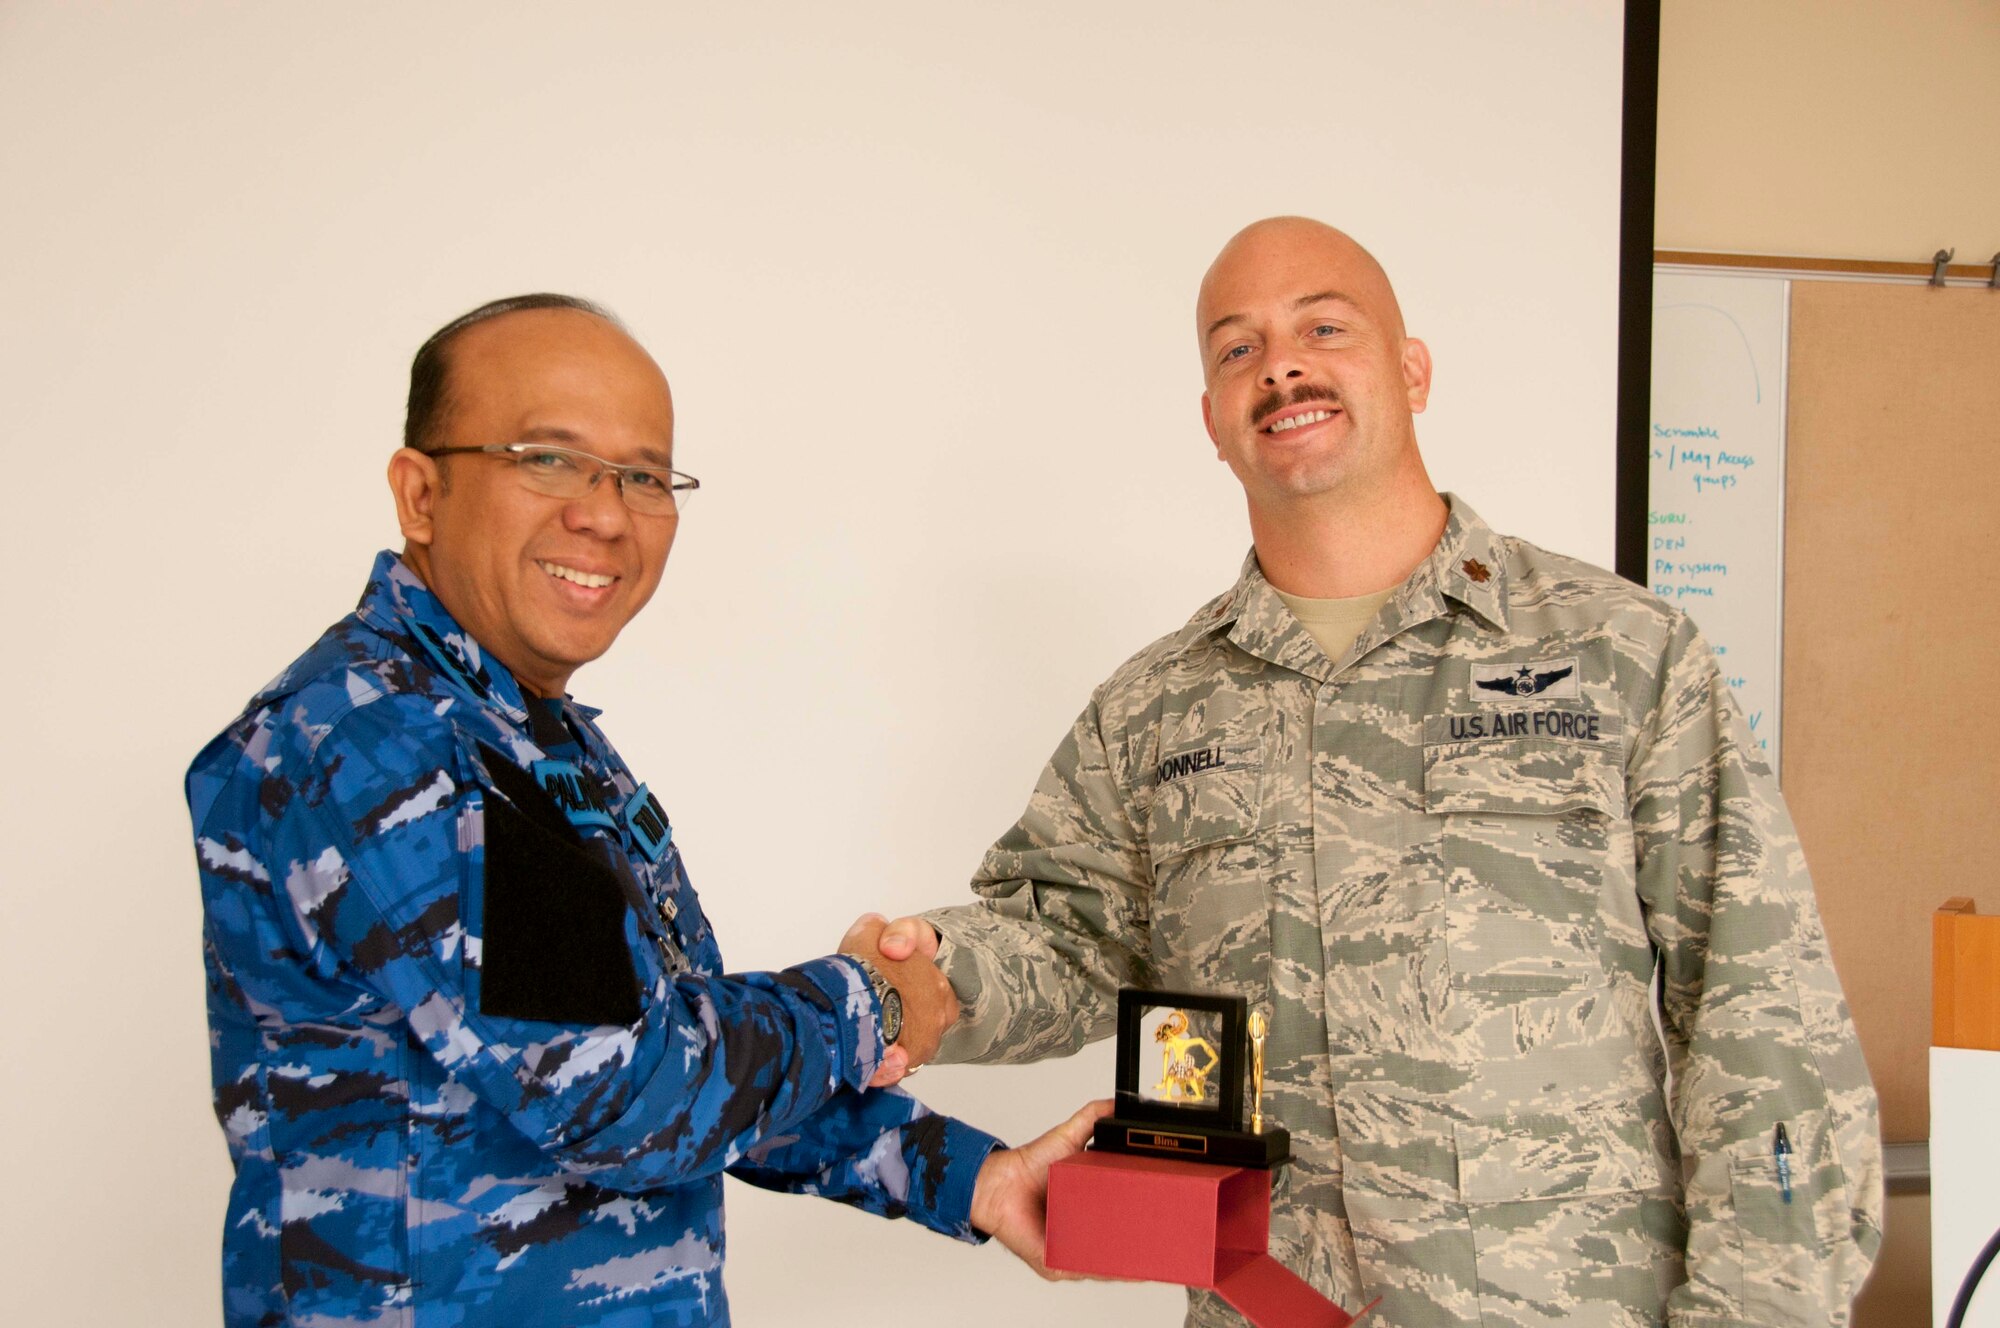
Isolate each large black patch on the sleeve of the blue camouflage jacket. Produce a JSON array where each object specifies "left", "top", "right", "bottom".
[{"left": 480, "top": 776, "right": 640, "bottom": 1024}]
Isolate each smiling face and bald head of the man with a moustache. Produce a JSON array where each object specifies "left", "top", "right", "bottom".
[{"left": 1196, "top": 218, "right": 1430, "bottom": 510}]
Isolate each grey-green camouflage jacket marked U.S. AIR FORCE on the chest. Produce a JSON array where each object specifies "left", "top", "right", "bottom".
[{"left": 930, "top": 500, "right": 1882, "bottom": 1328}]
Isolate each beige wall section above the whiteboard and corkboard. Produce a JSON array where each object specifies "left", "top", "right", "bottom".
[{"left": 1654, "top": 0, "right": 2000, "bottom": 262}]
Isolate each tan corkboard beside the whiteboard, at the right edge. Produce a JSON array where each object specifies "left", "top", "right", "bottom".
[{"left": 1784, "top": 280, "right": 2000, "bottom": 1142}]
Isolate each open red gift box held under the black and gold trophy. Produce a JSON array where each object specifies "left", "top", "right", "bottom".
[{"left": 1044, "top": 1152, "right": 1374, "bottom": 1328}]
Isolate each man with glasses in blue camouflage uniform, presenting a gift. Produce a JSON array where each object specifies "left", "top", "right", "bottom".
[{"left": 188, "top": 296, "right": 1092, "bottom": 1328}]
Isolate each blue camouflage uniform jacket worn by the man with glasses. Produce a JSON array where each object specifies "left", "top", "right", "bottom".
[{"left": 188, "top": 552, "right": 996, "bottom": 1328}]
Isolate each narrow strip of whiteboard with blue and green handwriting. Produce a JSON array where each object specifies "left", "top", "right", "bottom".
[{"left": 1646, "top": 268, "right": 1790, "bottom": 770}]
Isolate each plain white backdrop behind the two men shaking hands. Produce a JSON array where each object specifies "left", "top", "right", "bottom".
[{"left": 0, "top": 0, "right": 1620, "bottom": 1326}]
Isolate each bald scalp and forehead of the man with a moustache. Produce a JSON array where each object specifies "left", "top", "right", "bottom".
[{"left": 1194, "top": 216, "right": 1404, "bottom": 364}]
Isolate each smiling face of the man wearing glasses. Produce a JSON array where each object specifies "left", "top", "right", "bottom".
[{"left": 390, "top": 310, "right": 676, "bottom": 696}]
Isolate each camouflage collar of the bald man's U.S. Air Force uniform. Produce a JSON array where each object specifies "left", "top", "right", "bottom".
[{"left": 1212, "top": 494, "right": 1508, "bottom": 682}]
